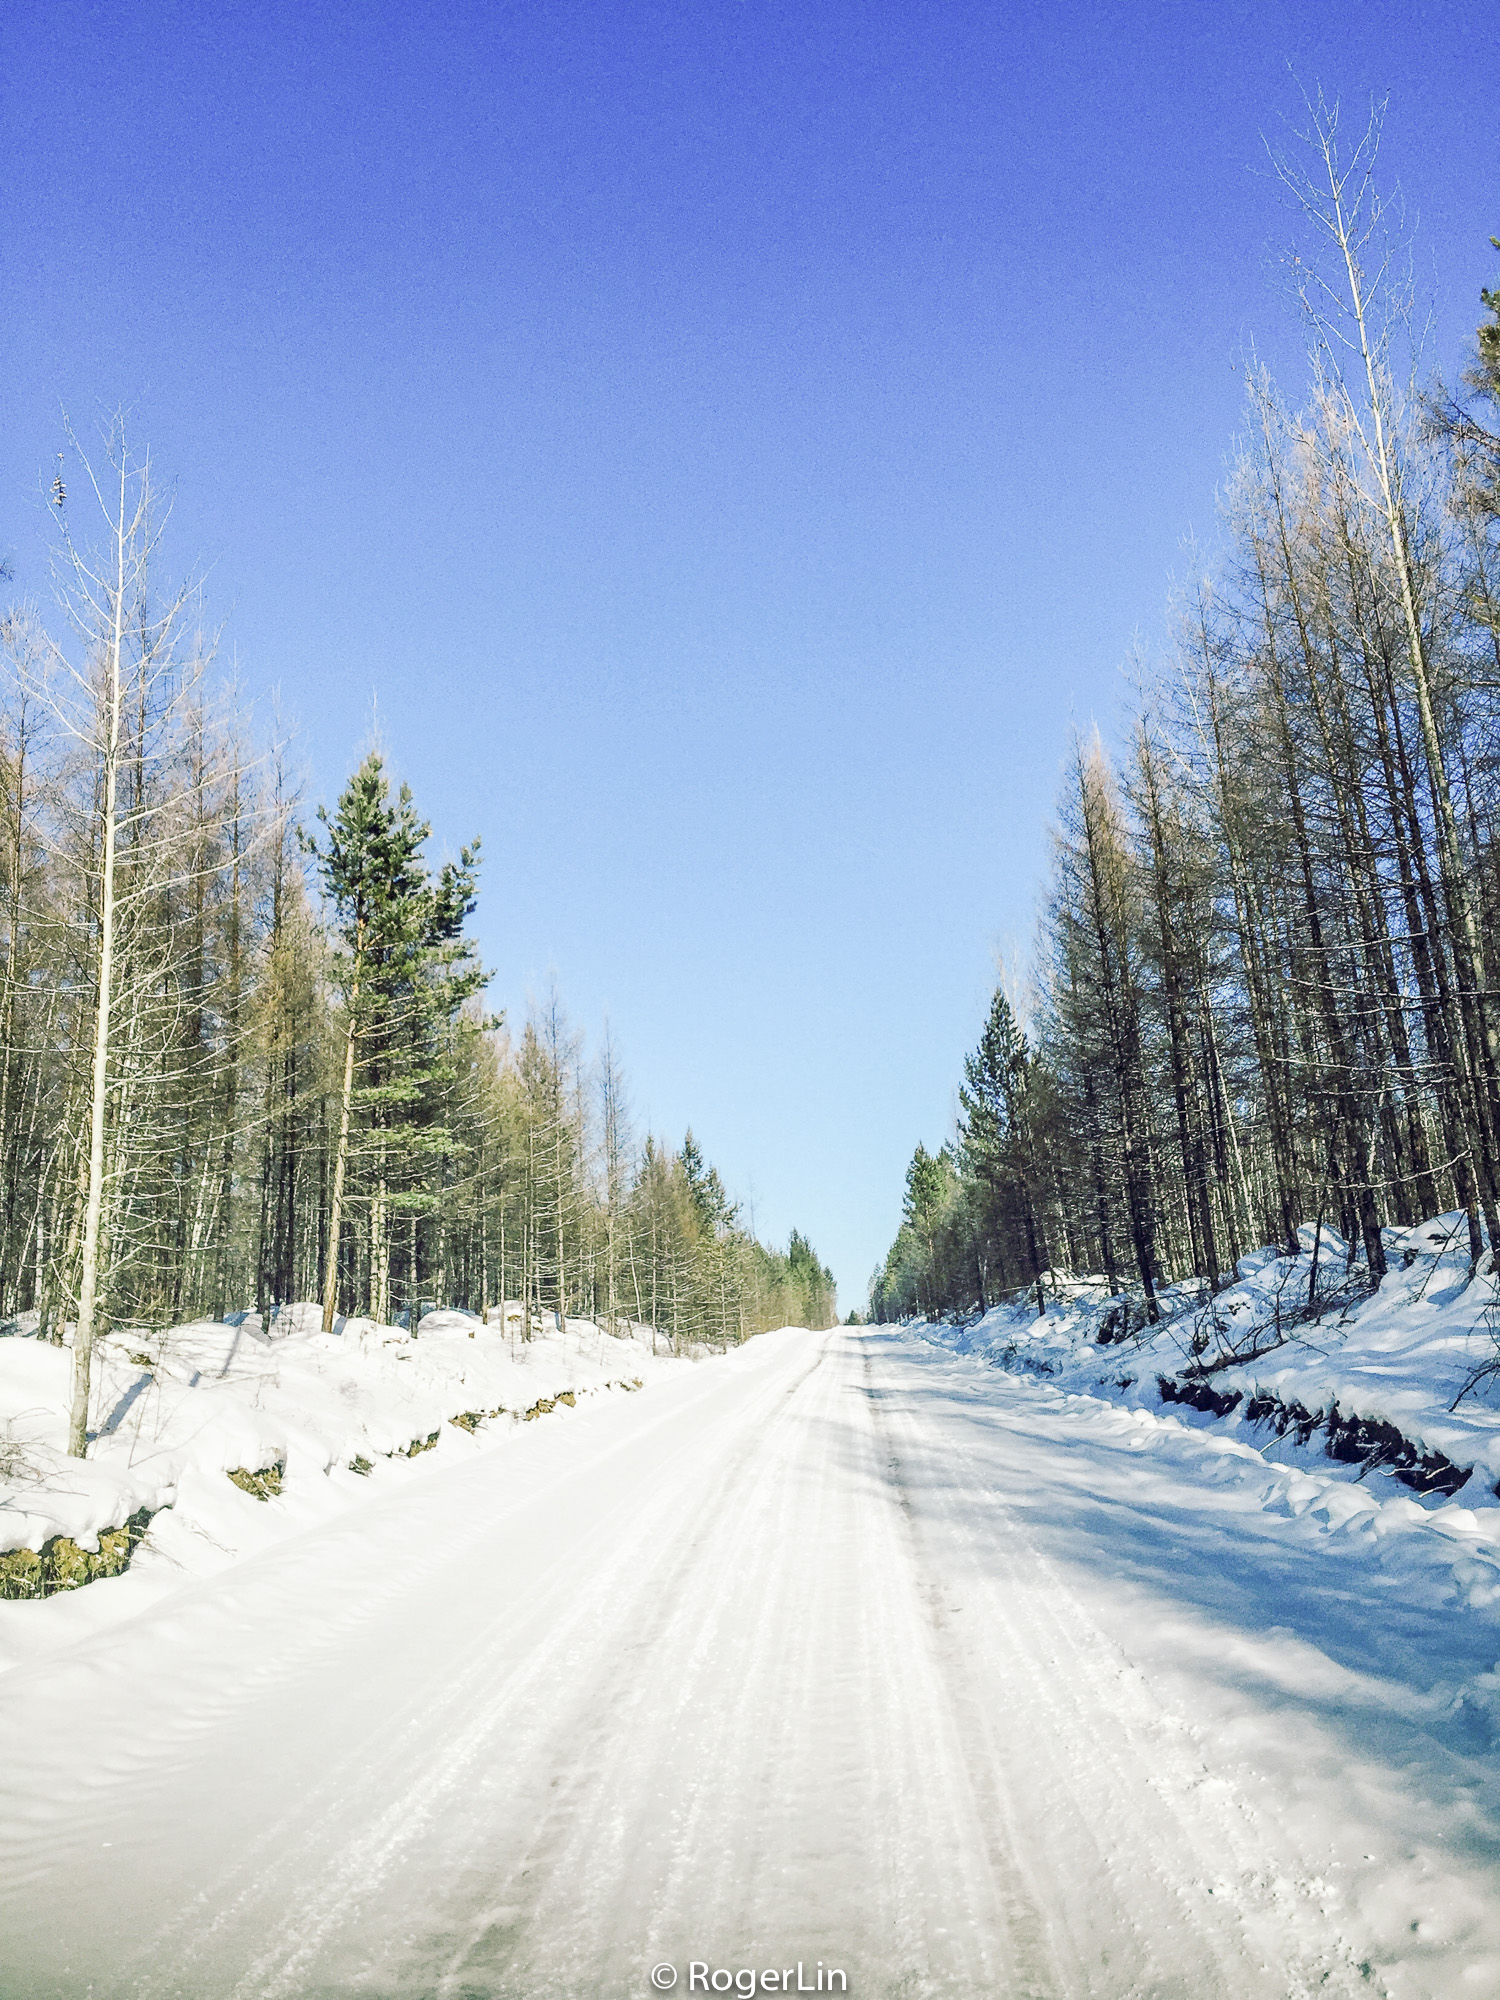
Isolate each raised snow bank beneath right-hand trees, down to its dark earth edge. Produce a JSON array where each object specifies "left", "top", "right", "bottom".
[{"left": 924, "top": 1214, "right": 1500, "bottom": 1544}]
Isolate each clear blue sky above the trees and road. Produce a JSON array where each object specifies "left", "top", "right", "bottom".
[{"left": 0, "top": 0, "right": 1500, "bottom": 1306}]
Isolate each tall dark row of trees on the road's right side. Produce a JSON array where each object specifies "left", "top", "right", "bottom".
[{"left": 872, "top": 102, "right": 1500, "bottom": 1320}]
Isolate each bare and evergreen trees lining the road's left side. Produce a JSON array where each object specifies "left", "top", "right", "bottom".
[{"left": 0, "top": 446, "right": 834, "bottom": 1452}]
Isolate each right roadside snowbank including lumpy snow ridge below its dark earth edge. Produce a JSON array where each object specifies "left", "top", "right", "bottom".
[{"left": 908, "top": 1216, "right": 1500, "bottom": 1632}]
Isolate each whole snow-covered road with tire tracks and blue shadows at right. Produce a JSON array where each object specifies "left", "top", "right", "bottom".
[{"left": 0, "top": 1328, "right": 1500, "bottom": 2000}]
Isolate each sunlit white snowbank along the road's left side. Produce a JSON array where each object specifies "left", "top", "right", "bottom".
[{"left": 0, "top": 1306, "right": 688, "bottom": 1668}]
